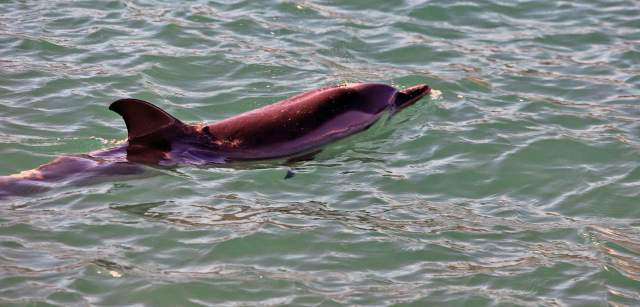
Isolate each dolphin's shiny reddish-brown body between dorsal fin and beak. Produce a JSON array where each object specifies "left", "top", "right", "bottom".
[{"left": 203, "top": 84, "right": 396, "bottom": 156}]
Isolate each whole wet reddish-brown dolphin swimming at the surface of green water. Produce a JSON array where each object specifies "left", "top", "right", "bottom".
[{"left": 0, "top": 83, "right": 431, "bottom": 196}]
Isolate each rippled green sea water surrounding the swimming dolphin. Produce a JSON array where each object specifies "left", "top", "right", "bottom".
[{"left": 0, "top": 0, "right": 640, "bottom": 306}]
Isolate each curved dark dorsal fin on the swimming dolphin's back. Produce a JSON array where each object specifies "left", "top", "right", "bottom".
[{"left": 109, "top": 98, "right": 184, "bottom": 143}]
